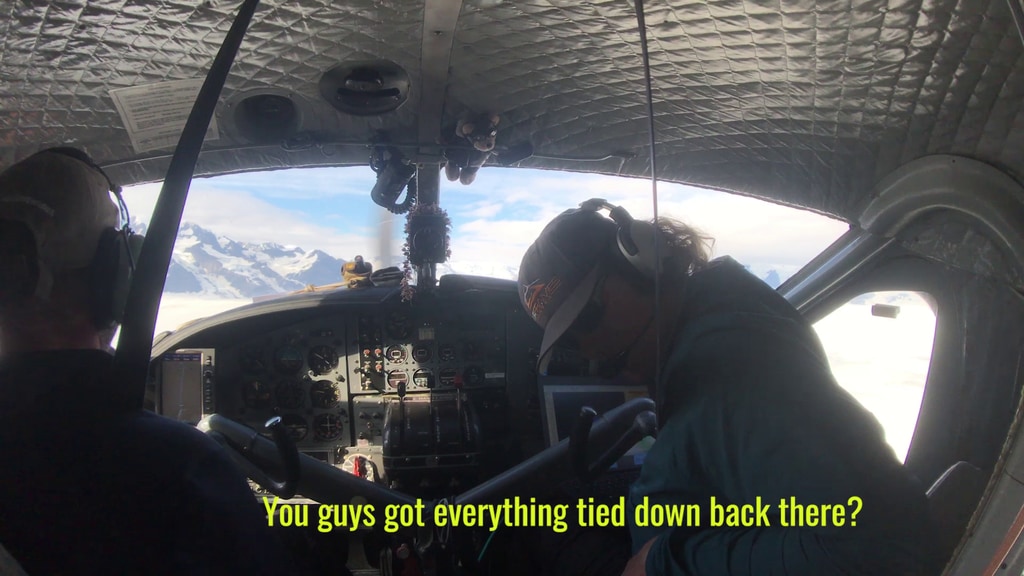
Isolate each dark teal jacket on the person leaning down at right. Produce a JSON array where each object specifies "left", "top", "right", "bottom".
[{"left": 629, "top": 258, "right": 929, "bottom": 576}]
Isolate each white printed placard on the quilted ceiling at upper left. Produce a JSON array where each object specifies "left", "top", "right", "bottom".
[{"left": 111, "top": 79, "right": 220, "bottom": 154}]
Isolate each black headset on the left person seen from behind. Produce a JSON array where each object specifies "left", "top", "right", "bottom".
[{"left": 3, "top": 147, "right": 143, "bottom": 330}]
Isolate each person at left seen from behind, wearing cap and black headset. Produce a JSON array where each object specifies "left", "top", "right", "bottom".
[{"left": 0, "top": 148, "right": 291, "bottom": 574}]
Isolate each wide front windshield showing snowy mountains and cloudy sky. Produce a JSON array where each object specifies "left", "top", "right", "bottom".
[{"left": 125, "top": 163, "right": 848, "bottom": 333}]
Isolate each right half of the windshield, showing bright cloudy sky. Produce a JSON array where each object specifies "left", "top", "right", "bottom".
[{"left": 442, "top": 169, "right": 849, "bottom": 277}]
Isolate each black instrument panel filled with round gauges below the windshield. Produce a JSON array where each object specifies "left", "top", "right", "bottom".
[{"left": 155, "top": 292, "right": 565, "bottom": 497}]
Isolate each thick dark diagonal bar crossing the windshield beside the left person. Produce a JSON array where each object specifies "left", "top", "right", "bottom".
[{"left": 114, "top": 0, "right": 259, "bottom": 406}]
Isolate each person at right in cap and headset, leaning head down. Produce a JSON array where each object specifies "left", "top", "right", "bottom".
[{"left": 519, "top": 200, "right": 929, "bottom": 576}]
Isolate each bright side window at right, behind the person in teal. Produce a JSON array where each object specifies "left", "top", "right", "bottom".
[{"left": 814, "top": 292, "right": 935, "bottom": 461}]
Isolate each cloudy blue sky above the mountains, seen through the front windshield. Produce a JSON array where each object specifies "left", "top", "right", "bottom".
[{"left": 125, "top": 167, "right": 848, "bottom": 278}]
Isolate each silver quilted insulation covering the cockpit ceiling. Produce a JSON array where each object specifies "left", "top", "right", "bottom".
[{"left": 0, "top": 0, "right": 1024, "bottom": 219}]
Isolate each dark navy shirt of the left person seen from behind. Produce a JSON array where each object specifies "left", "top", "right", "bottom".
[{"left": 0, "top": 351, "right": 291, "bottom": 574}]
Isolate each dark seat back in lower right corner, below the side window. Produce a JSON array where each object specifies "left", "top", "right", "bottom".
[{"left": 928, "top": 461, "right": 988, "bottom": 565}]
